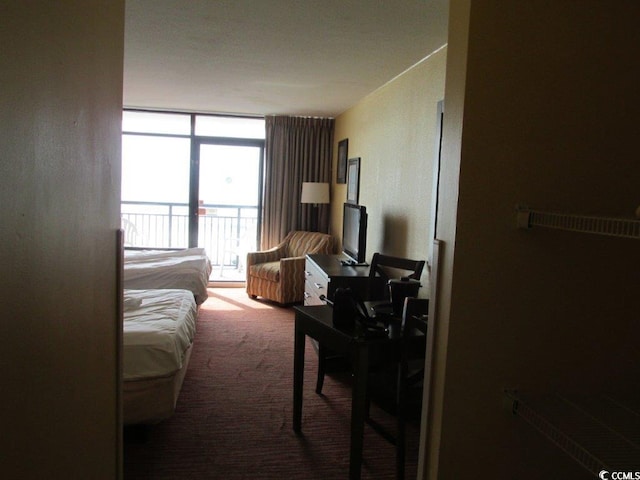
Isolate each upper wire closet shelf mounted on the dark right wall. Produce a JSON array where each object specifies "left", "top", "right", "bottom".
[{"left": 517, "top": 207, "right": 640, "bottom": 239}]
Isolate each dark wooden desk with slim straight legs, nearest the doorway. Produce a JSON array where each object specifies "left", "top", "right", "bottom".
[{"left": 293, "top": 305, "right": 402, "bottom": 479}]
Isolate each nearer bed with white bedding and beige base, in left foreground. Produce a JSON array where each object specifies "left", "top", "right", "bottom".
[{"left": 122, "top": 289, "right": 198, "bottom": 425}]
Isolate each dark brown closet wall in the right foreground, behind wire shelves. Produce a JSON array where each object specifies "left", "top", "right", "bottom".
[{"left": 428, "top": 0, "right": 640, "bottom": 480}]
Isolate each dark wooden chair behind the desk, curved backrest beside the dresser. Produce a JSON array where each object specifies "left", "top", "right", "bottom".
[{"left": 316, "top": 252, "right": 425, "bottom": 395}]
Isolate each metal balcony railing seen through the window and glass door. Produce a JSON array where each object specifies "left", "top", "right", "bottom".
[{"left": 121, "top": 202, "right": 258, "bottom": 278}]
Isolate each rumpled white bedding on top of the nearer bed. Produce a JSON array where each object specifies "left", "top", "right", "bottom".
[{"left": 123, "top": 289, "right": 197, "bottom": 381}]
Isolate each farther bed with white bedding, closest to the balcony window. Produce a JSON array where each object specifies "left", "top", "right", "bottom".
[{"left": 124, "top": 248, "right": 211, "bottom": 305}]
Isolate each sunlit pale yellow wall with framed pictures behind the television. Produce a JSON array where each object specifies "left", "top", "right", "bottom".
[{"left": 331, "top": 48, "right": 446, "bottom": 295}]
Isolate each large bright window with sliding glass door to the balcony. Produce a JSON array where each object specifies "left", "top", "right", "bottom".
[{"left": 121, "top": 110, "right": 265, "bottom": 273}]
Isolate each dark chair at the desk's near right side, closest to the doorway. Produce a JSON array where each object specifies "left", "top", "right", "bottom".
[{"left": 366, "top": 297, "right": 429, "bottom": 480}]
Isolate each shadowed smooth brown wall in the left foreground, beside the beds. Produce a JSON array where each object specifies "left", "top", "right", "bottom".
[{"left": 0, "top": 0, "right": 124, "bottom": 479}]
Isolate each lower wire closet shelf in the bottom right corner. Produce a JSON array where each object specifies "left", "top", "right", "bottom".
[{"left": 505, "top": 390, "right": 640, "bottom": 476}]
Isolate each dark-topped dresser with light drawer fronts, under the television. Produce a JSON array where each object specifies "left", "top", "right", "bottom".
[{"left": 304, "top": 254, "right": 386, "bottom": 305}]
